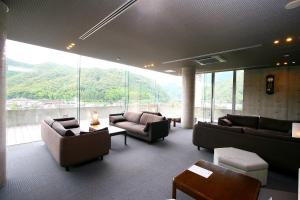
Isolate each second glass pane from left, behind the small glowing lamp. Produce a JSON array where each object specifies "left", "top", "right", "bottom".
[{"left": 80, "top": 56, "right": 127, "bottom": 123}]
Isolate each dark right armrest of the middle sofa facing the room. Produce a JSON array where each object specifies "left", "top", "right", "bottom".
[{"left": 148, "top": 120, "right": 169, "bottom": 142}]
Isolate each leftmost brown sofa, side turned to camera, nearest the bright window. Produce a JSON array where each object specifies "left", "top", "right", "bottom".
[{"left": 41, "top": 118, "right": 110, "bottom": 171}]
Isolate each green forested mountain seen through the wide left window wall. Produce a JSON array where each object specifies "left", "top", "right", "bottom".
[{"left": 7, "top": 59, "right": 172, "bottom": 104}]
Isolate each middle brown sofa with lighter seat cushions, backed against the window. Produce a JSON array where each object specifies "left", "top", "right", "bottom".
[{"left": 109, "top": 112, "right": 170, "bottom": 142}]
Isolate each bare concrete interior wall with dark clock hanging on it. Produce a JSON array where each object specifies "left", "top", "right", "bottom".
[{"left": 243, "top": 66, "right": 300, "bottom": 120}]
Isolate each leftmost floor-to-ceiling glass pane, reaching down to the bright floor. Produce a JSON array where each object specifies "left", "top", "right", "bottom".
[{"left": 6, "top": 40, "right": 79, "bottom": 145}]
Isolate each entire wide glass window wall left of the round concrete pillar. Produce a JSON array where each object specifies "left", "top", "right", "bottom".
[{"left": 6, "top": 40, "right": 181, "bottom": 145}]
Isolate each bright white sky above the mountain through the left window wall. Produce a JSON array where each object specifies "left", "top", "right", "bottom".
[{"left": 5, "top": 40, "right": 181, "bottom": 85}]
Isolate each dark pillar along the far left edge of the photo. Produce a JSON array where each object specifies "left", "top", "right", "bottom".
[{"left": 0, "top": 1, "right": 8, "bottom": 188}]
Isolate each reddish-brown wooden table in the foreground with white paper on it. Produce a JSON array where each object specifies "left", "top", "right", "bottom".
[{"left": 172, "top": 161, "right": 261, "bottom": 200}]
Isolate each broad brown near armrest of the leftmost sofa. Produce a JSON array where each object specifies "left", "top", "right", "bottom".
[{"left": 60, "top": 130, "right": 111, "bottom": 166}]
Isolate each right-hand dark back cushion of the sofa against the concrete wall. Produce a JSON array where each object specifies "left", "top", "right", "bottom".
[{"left": 259, "top": 117, "right": 293, "bottom": 133}]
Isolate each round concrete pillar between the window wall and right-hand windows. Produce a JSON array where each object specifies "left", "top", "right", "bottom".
[{"left": 181, "top": 66, "right": 196, "bottom": 128}]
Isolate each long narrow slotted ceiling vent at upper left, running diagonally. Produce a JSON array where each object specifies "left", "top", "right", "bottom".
[{"left": 79, "top": 0, "right": 137, "bottom": 40}]
